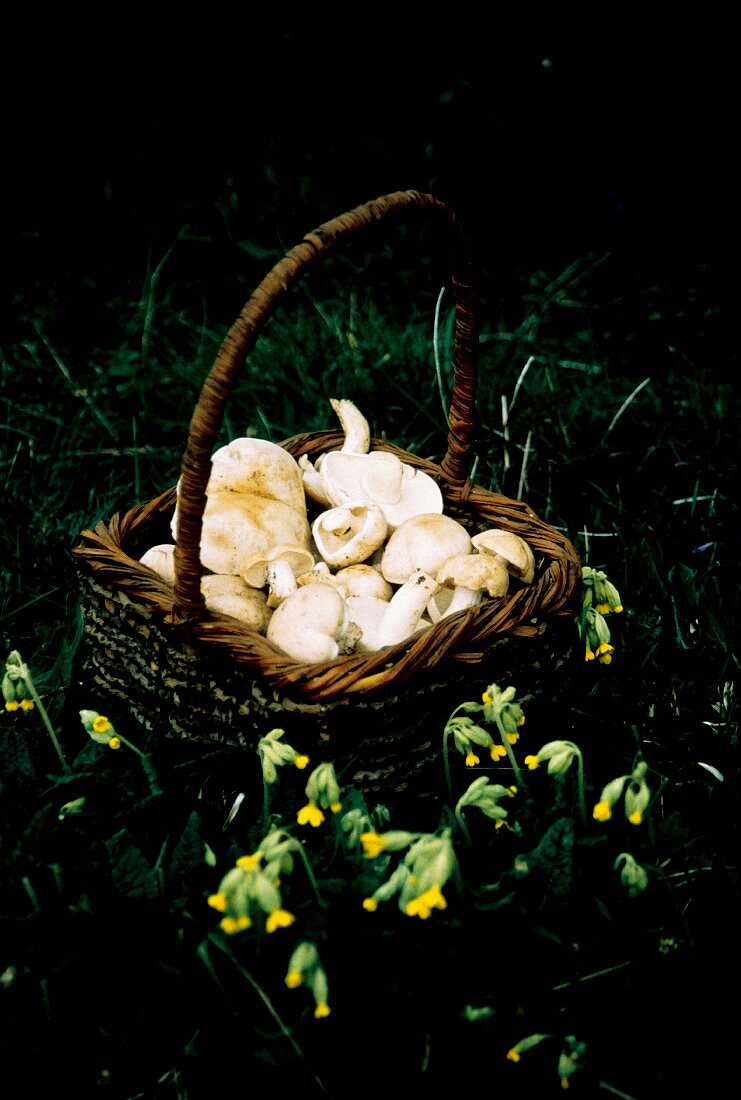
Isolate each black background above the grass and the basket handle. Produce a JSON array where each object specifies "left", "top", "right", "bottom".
[{"left": 2, "top": 24, "right": 738, "bottom": 343}]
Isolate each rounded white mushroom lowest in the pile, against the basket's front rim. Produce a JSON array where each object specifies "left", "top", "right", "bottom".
[{"left": 267, "top": 584, "right": 362, "bottom": 661}]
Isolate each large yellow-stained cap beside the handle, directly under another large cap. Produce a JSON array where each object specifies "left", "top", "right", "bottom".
[{"left": 173, "top": 492, "right": 311, "bottom": 574}]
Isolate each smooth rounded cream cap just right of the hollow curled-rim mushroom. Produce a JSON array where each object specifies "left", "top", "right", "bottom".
[{"left": 380, "top": 513, "right": 472, "bottom": 584}]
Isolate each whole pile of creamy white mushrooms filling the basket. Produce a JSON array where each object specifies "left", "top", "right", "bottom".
[{"left": 141, "top": 399, "right": 534, "bottom": 662}]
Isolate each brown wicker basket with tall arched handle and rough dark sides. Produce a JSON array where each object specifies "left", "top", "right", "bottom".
[{"left": 74, "top": 191, "right": 580, "bottom": 791}]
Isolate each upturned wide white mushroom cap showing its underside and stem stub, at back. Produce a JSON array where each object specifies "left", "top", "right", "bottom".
[{"left": 321, "top": 451, "right": 443, "bottom": 531}]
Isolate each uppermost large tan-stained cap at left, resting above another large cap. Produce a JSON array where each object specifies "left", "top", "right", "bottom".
[{"left": 206, "top": 438, "right": 306, "bottom": 512}]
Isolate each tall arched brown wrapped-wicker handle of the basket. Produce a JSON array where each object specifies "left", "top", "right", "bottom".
[{"left": 173, "top": 191, "right": 478, "bottom": 623}]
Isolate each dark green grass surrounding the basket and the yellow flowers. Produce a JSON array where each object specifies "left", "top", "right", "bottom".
[{"left": 0, "top": 218, "right": 740, "bottom": 1100}]
